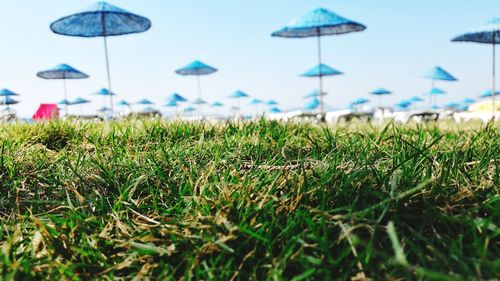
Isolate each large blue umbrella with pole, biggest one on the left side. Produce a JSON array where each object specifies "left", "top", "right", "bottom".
[{"left": 50, "top": 2, "right": 151, "bottom": 115}]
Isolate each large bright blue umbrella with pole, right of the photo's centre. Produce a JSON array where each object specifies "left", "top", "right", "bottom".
[{"left": 271, "top": 8, "right": 366, "bottom": 113}]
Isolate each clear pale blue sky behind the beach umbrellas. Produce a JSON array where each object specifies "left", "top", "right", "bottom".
[{"left": 0, "top": 0, "right": 500, "bottom": 117}]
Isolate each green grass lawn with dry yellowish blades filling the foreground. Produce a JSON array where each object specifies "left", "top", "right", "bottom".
[{"left": 0, "top": 120, "right": 500, "bottom": 281}]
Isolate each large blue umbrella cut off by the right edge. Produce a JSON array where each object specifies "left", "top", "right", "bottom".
[{"left": 451, "top": 18, "right": 500, "bottom": 119}]
